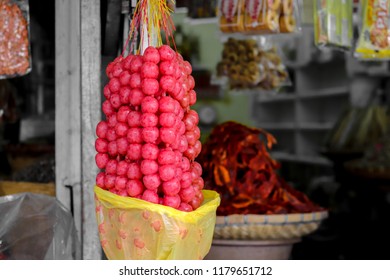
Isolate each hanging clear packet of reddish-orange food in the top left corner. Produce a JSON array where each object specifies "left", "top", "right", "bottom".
[{"left": 0, "top": 0, "right": 31, "bottom": 79}]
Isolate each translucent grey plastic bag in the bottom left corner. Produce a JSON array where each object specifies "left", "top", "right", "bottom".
[{"left": 0, "top": 193, "right": 81, "bottom": 260}]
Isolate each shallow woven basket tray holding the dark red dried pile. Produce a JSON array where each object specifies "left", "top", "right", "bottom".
[{"left": 214, "top": 211, "right": 328, "bottom": 240}]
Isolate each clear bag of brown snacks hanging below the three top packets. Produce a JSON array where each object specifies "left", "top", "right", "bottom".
[{"left": 217, "top": 37, "right": 291, "bottom": 90}]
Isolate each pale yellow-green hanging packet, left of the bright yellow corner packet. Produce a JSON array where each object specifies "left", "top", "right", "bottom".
[{"left": 314, "top": 0, "right": 353, "bottom": 50}]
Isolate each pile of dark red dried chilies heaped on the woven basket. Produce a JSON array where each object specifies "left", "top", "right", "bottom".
[{"left": 198, "top": 122, "right": 323, "bottom": 216}]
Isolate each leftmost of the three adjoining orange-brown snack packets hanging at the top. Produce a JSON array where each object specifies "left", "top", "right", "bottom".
[{"left": 218, "top": 0, "right": 244, "bottom": 33}]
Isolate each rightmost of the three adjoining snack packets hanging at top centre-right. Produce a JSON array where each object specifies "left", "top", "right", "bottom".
[{"left": 279, "top": 0, "right": 299, "bottom": 33}]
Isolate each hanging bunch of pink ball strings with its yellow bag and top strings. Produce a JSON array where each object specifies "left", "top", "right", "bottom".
[{"left": 95, "top": 0, "right": 219, "bottom": 260}]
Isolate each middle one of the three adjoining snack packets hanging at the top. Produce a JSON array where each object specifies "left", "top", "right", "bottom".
[{"left": 245, "top": 0, "right": 281, "bottom": 34}]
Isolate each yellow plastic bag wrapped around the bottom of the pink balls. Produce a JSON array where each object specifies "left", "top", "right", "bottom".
[{"left": 95, "top": 187, "right": 220, "bottom": 260}]
